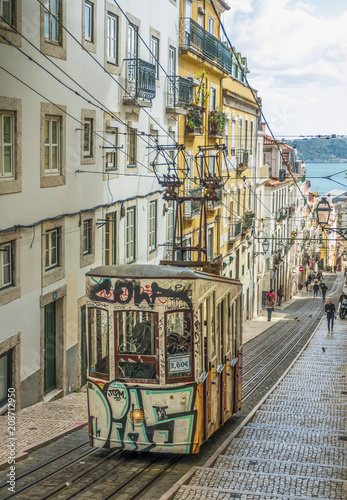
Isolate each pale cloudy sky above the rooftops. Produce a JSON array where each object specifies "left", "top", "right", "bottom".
[{"left": 223, "top": 0, "right": 347, "bottom": 138}]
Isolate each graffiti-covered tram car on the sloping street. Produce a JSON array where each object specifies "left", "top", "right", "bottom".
[{"left": 87, "top": 265, "right": 242, "bottom": 454}]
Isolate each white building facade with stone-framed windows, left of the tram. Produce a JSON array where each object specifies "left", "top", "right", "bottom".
[{"left": 0, "top": 0, "right": 178, "bottom": 406}]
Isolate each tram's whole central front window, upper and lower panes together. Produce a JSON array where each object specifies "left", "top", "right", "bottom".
[{"left": 115, "top": 311, "right": 158, "bottom": 380}]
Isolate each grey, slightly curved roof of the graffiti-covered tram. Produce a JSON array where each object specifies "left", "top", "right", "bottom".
[{"left": 86, "top": 264, "right": 241, "bottom": 284}]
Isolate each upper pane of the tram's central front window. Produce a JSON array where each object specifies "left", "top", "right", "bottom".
[{"left": 117, "top": 311, "right": 157, "bottom": 356}]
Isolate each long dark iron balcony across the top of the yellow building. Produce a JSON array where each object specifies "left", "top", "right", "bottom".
[{"left": 180, "top": 17, "right": 231, "bottom": 73}]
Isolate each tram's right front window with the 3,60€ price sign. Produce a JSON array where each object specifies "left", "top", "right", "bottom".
[{"left": 166, "top": 311, "right": 193, "bottom": 378}]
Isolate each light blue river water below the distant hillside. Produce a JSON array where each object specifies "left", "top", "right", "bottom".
[{"left": 306, "top": 162, "right": 347, "bottom": 195}]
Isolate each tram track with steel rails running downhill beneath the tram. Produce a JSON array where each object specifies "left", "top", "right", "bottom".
[{"left": 0, "top": 280, "right": 341, "bottom": 500}]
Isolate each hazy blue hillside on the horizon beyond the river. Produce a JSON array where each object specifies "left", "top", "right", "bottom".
[{"left": 284, "top": 137, "right": 347, "bottom": 162}]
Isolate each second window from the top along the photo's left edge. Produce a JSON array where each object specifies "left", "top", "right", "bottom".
[{"left": 0, "top": 111, "right": 14, "bottom": 177}]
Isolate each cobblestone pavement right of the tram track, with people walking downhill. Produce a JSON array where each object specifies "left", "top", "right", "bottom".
[{"left": 162, "top": 312, "right": 347, "bottom": 500}]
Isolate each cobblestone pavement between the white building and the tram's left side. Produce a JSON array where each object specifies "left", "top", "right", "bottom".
[{"left": 0, "top": 391, "right": 88, "bottom": 469}]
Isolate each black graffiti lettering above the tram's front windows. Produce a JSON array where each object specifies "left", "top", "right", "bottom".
[{"left": 88, "top": 279, "right": 193, "bottom": 309}]
